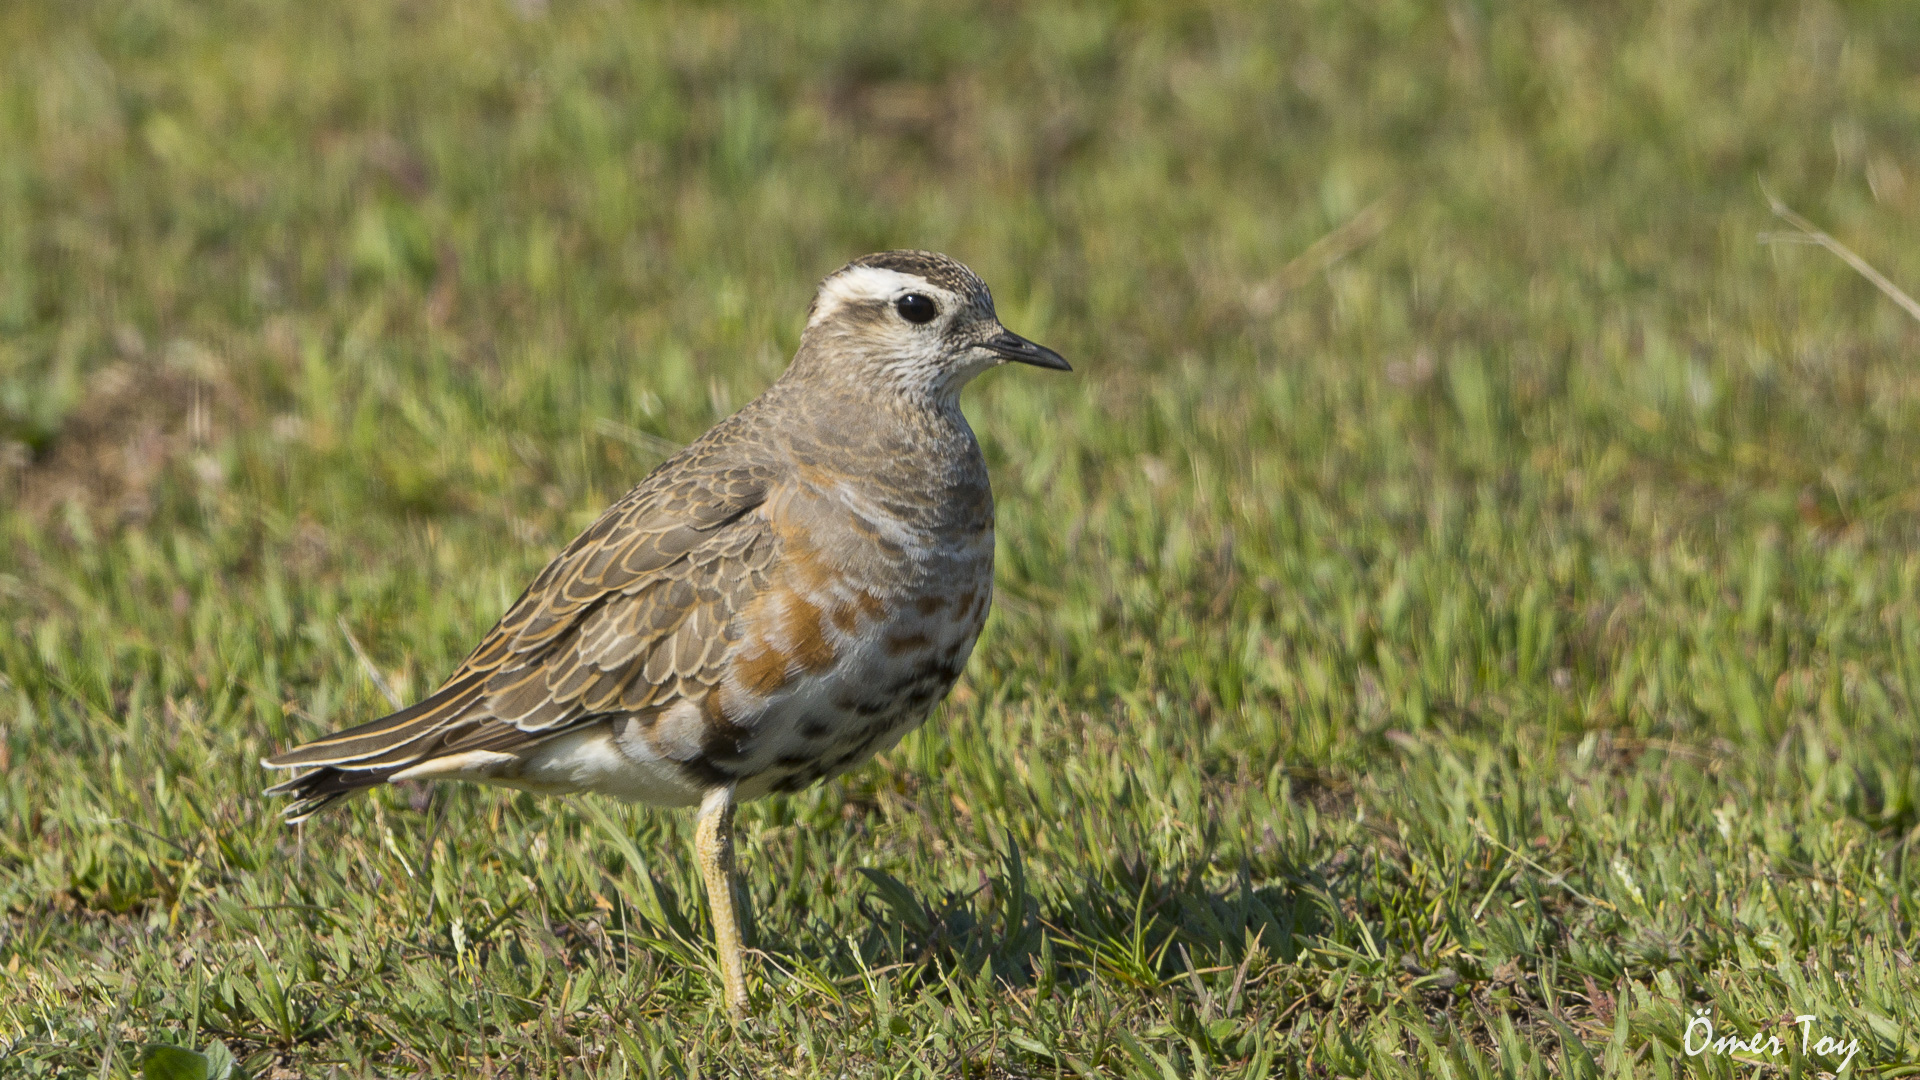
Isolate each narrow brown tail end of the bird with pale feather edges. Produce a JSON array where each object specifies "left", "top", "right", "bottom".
[{"left": 261, "top": 673, "right": 486, "bottom": 824}]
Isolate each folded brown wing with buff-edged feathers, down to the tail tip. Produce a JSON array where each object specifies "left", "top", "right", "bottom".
[{"left": 265, "top": 425, "right": 778, "bottom": 819}]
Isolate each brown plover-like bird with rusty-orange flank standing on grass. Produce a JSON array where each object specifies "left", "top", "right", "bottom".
[{"left": 261, "top": 250, "right": 1071, "bottom": 1017}]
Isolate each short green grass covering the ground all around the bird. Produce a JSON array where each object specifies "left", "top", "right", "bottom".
[{"left": 0, "top": 0, "right": 1920, "bottom": 1078}]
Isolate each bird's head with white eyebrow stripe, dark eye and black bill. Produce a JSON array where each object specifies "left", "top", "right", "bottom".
[{"left": 795, "top": 252, "right": 1071, "bottom": 402}]
